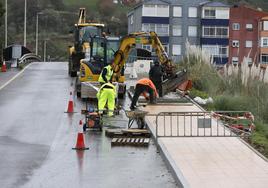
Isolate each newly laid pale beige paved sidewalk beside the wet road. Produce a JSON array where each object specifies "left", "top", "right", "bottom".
[{"left": 143, "top": 104, "right": 268, "bottom": 188}]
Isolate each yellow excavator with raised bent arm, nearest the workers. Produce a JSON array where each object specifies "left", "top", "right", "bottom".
[{"left": 77, "top": 32, "right": 186, "bottom": 98}]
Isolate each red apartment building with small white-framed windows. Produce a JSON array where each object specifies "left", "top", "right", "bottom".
[{"left": 229, "top": 5, "right": 268, "bottom": 65}]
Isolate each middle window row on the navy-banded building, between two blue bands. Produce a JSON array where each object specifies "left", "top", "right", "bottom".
[{"left": 203, "top": 26, "right": 229, "bottom": 38}]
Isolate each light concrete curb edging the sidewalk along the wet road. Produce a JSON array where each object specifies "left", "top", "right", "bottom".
[{"left": 145, "top": 117, "right": 190, "bottom": 188}]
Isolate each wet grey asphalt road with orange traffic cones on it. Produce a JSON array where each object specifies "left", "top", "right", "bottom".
[{"left": 0, "top": 63, "right": 176, "bottom": 188}]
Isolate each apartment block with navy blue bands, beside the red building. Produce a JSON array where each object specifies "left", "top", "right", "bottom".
[{"left": 201, "top": 2, "right": 230, "bottom": 66}]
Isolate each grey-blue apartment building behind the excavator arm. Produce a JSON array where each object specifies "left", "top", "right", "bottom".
[{"left": 128, "top": 0, "right": 207, "bottom": 61}]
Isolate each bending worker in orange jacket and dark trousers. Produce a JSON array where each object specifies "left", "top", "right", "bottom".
[{"left": 130, "top": 78, "right": 158, "bottom": 110}]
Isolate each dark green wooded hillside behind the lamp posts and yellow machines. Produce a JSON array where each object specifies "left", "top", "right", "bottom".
[{"left": 0, "top": 0, "right": 129, "bottom": 61}]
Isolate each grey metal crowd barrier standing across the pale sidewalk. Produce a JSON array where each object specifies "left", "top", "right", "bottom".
[{"left": 156, "top": 111, "right": 254, "bottom": 143}]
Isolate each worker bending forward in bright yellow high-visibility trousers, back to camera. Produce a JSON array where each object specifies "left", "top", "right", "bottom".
[{"left": 97, "top": 82, "right": 116, "bottom": 116}]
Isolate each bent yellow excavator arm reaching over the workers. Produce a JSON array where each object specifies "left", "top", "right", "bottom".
[{"left": 113, "top": 32, "right": 175, "bottom": 77}]
